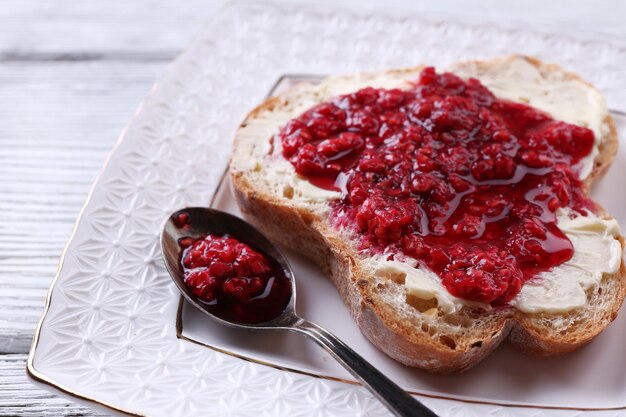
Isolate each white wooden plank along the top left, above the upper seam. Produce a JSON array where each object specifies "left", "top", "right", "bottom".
[{"left": 0, "top": 0, "right": 222, "bottom": 61}]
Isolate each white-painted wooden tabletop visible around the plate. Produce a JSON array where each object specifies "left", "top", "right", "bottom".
[{"left": 0, "top": 0, "right": 626, "bottom": 416}]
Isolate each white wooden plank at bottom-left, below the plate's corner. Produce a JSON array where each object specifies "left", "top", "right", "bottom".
[{"left": 0, "top": 354, "right": 105, "bottom": 417}]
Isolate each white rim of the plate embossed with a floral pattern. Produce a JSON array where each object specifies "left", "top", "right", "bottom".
[{"left": 29, "top": 1, "right": 626, "bottom": 416}]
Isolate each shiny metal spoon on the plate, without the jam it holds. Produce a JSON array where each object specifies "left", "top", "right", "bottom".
[{"left": 161, "top": 207, "right": 436, "bottom": 417}]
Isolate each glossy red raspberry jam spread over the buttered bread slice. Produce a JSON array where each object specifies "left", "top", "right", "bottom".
[{"left": 277, "top": 68, "right": 594, "bottom": 305}]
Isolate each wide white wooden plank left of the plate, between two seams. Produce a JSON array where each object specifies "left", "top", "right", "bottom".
[{"left": 0, "top": 61, "right": 165, "bottom": 353}]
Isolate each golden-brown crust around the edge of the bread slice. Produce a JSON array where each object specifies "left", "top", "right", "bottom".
[{"left": 230, "top": 56, "right": 626, "bottom": 373}]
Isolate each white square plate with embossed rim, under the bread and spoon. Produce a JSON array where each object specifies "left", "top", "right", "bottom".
[{"left": 28, "top": 1, "right": 626, "bottom": 416}]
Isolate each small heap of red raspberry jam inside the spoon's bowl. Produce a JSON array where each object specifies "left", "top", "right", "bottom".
[{"left": 179, "top": 234, "right": 291, "bottom": 324}]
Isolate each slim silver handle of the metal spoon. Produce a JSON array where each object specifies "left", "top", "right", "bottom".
[{"left": 290, "top": 319, "right": 437, "bottom": 417}]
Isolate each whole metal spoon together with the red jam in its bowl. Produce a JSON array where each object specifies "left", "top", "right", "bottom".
[{"left": 161, "top": 207, "right": 436, "bottom": 417}]
